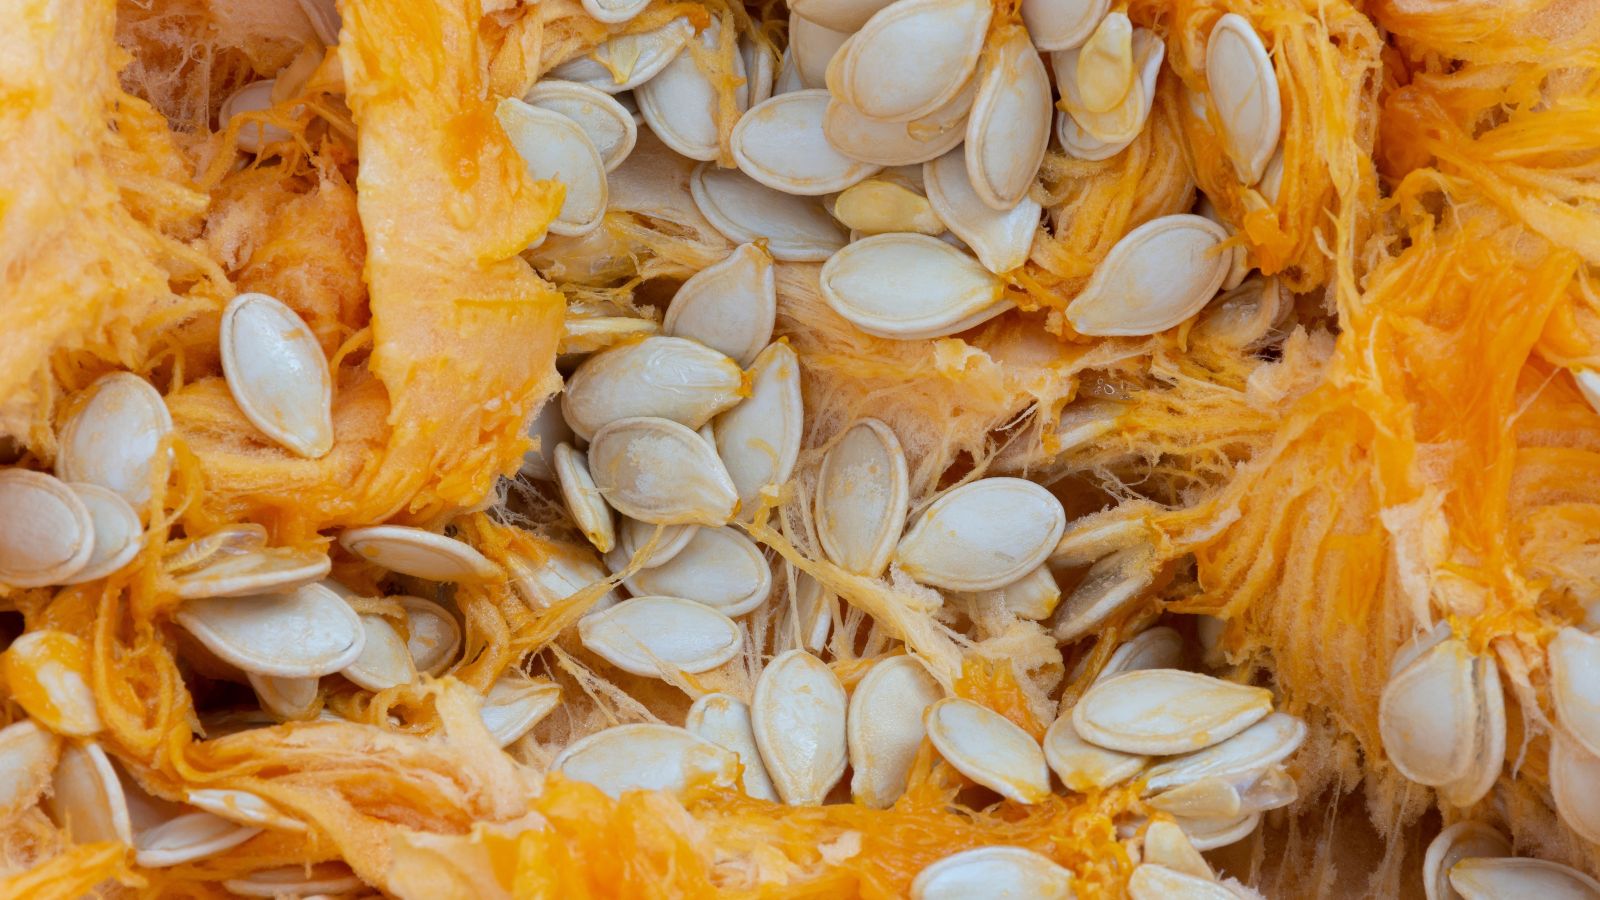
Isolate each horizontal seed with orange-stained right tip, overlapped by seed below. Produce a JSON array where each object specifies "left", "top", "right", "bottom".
[{"left": 562, "top": 336, "right": 744, "bottom": 440}]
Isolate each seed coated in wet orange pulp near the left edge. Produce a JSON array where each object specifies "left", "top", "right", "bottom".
[{"left": 0, "top": 628, "right": 104, "bottom": 737}]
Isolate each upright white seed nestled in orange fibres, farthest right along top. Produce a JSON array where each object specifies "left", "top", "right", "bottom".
[{"left": 1205, "top": 13, "right": 1283, "bottom": 184}]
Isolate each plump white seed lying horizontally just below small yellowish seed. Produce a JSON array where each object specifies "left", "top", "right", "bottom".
[{"left": 821, "top": 234, "right": 1013, "bottom": 341}]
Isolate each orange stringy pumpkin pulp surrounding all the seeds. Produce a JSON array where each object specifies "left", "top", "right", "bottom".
[{"left": 0, "top": 0, "right": 1600, "bottom": 898}]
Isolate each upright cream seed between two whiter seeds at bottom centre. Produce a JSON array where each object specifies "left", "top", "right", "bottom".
[{"left": 845, "top": 657, "right": 944, "bottom": 809}]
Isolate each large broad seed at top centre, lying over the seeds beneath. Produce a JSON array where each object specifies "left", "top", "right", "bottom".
[{"left": 827, "top": 0, "right": 994, "bottom": 122}]
